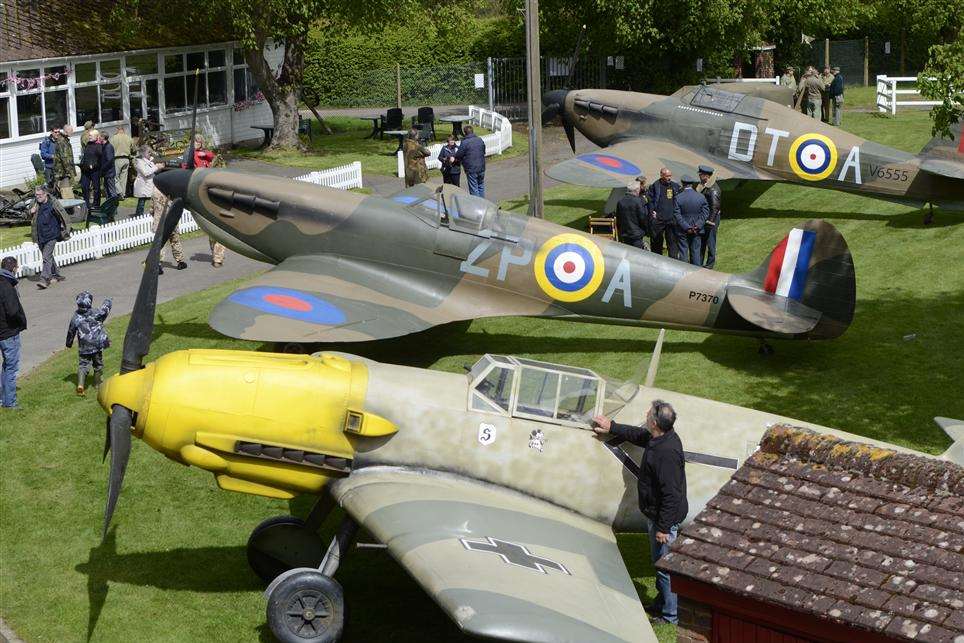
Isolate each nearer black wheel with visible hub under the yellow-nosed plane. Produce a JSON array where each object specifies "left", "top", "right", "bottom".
[{"left": 266, "top": 570, "right": 345, "bottom": 643}]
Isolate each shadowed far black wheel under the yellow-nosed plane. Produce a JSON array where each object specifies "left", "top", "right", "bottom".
[{"left": 247, "top": 516, "right": 327, "bottom": 584}]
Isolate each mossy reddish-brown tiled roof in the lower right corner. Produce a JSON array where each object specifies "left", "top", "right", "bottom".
[{"left": 657, "top": 426, "right": 964, "bottom": 643}]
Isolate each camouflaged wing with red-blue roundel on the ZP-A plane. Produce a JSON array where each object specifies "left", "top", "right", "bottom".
[{"left": 208, "top": 255, "right": 553, "bottom": 342}]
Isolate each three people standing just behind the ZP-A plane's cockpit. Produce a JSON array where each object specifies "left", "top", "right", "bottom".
[{"left": 402, "top": 125, "right": 485, "bottom": 198}]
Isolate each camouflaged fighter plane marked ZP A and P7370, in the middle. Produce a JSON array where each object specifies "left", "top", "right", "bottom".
[{"left": 155, "top": 169, "right": 856, "bottom": 343}]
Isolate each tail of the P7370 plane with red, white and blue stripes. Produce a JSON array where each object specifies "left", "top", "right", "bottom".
[{"left": 727, "top": 219, "right": 857, "bottom": 339}]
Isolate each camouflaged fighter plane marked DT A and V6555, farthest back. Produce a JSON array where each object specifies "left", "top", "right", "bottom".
[{"left": 543, "top": 85, "right": 964, "bottom": 211}]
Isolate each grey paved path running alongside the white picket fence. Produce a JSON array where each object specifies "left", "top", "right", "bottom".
[{"left": 19, "top": 128, "right": 594, "bottom": 374}]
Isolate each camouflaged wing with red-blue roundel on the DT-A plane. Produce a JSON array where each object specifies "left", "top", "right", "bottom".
[{"left": 546, "top": 137, "right": 772, "bottom": 188}]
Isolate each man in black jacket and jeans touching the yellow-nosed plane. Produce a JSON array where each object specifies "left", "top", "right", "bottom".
[{"left": 593, "top": 400, "right": 689, "bottom": 623}]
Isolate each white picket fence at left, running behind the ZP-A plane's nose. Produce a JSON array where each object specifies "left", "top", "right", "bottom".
[{"left": 0, "top": 161, "right": 362, "bottom": 276}]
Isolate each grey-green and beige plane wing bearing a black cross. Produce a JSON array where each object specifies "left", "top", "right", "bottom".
[{"left": 332, "top": 467, "right": 656, "bottom": 643}]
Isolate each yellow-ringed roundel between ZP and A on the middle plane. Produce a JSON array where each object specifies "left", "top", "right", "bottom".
[{"left": 533, "top": 234, "right": 606, "bottom": 302}]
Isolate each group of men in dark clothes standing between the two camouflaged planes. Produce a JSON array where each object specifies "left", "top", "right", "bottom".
[{"left": 616, "top": 165, "right": 723, "bottom": 269}]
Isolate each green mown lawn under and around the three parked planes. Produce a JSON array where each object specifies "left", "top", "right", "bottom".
[{"left": 0, "top": 104, "right": 964, "bottom": 642}]
